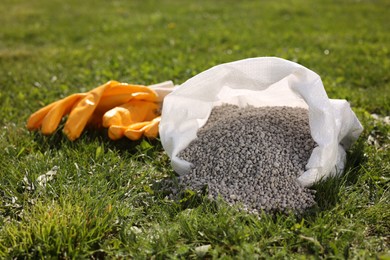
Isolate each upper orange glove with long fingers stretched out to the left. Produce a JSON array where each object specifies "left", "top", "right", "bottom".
[{"left": 27, "top": 81, "right": 158, "bottom": 141}]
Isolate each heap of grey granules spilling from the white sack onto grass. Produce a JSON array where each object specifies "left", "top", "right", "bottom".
[{"left": 178, "top": 105, "right": 316, "bottom": 213}]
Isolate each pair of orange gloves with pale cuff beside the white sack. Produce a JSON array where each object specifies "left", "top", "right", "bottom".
[{"left": 27, "top": 81, "right": 173, "bottom": 141}]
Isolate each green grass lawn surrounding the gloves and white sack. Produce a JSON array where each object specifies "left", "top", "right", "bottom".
[{"left": 0, "top": 0, "right": 390, "bottom": 259}]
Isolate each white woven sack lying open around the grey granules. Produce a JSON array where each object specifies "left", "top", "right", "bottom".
[{"left": 159, "top": 57, "right": 363, "bottom": 186}]
